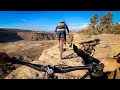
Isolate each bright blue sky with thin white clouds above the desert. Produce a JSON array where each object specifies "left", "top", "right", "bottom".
[{"left": 0, "top": 11, "right": 120, "bottom": 31}]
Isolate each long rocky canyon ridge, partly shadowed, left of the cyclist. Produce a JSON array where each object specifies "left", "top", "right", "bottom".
[{"left": 0, "top": 28, "right": 55, "bottom": 43}]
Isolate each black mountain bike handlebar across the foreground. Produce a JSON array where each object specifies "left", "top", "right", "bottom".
[{"left": 7, "top": 58, "right": 104, "bottom": 77}]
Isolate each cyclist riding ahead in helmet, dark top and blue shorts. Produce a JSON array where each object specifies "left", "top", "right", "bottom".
[{"left": 55, "top": 20, "right": 69, "bottom": 50}]
